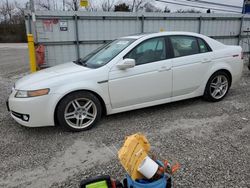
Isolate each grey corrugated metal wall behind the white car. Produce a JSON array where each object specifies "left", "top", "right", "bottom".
[{"left": 26, "top": 11, "right": 250, "bottom": 66}]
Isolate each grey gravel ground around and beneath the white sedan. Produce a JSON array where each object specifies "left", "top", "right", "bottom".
[{"left": 0, "top": 45, "right": 250, "bottom": 188}]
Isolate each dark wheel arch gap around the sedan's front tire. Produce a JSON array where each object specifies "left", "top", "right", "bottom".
[{"left": 53, "top": 89, "right": 107, "bottom": 125}]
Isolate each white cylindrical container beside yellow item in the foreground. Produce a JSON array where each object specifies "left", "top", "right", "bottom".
[{"left": 137, "top": 156, "right": 159, "bottom": 179}]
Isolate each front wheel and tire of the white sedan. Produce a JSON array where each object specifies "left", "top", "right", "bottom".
[{"left": 56, "top": 91, "right": 102, "bottom": 132}]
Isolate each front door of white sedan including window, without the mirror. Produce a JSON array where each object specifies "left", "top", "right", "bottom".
[{"left": 109, "top": 37, "right": 172, "bottom": 109}]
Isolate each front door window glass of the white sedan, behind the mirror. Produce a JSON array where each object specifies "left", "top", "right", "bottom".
[{"left": 124, "top": 37, "right": 166, "bottom": 65}]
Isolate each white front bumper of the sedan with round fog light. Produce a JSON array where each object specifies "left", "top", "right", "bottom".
[{"left": 6, "top": 91, "right": 59, "bottom": 127}]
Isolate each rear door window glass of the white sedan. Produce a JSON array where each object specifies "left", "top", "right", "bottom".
[{"left": 169, "top": 36, "right": 199, "bottom": 57}]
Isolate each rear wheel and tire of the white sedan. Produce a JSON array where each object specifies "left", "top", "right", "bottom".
[{"left": 203, "top": 71, "right": 231, "bottom": 102}]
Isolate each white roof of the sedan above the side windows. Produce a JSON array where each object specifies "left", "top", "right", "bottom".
[{"left": 122, "top": 31, "right": 204, "bottom": 39}]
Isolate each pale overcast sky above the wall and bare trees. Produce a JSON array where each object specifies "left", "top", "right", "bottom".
[{"left": 7, "top": 0, "right": 243, "bottom": 12}]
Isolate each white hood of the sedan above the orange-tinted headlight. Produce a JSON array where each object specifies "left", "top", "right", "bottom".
[{"left": 15, "top": 62, "right": 91, "bottom": 89}]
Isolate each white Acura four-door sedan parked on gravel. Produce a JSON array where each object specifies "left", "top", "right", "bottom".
[{"left": 7, "top": 32, "right": 243, "bottom": 131}]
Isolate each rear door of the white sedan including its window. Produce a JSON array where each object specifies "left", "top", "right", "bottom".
[{"left": 169, "top": 35, "right": 212, "bottom": 97}]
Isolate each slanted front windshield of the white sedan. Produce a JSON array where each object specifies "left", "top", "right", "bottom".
[{"left": 76, "top": 39, "right": 135, "bottom": 68}]
